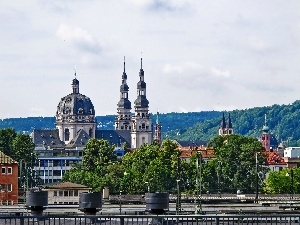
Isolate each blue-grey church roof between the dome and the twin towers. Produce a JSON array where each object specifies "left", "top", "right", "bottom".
[{"left": 96, "top": 130, "right": 131, "bottom": 146}]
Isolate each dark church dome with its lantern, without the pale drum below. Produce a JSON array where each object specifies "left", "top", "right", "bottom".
[{"left": 56, "top": 78, "right": 95, "bottom": 122}]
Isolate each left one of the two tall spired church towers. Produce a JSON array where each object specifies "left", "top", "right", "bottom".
[{"left": 115, "top": 57, "right": 131, "bottom": 130}]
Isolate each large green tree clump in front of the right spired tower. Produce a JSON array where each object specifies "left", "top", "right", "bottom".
[{"left": 122, "top": 140, "right": 179, "bottom": 194}]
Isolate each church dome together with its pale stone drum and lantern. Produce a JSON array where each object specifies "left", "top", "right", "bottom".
[{"left": 55, "top": 73, "right": 96, "bottom": 144}]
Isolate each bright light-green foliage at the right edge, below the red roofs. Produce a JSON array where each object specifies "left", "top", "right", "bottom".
[{"left": 263, "top": 168, "right": 300, "bottom": 194}]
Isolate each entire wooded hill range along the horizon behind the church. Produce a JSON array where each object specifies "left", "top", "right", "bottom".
[{"left": 0, "top": 100, "right": 300, "bottom": 146}]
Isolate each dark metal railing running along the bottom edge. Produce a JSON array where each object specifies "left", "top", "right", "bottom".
[{"left": 0, "top": 214, "right": 300, "bottom": 225}]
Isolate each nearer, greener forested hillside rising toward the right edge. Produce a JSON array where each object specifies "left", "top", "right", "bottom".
[{"left": 167, "top": 100, "right": 300, "bottom": 146}]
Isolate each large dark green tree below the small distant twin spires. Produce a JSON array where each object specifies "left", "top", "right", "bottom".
[{"left": 204, "top": 134, "right": 267, "bottom": 193}]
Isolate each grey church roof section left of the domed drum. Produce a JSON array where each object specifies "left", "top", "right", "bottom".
[{"left": 31, "top": 130, "right": 65, "bottom": 148}]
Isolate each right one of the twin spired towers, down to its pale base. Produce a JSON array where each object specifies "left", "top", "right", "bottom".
[{"left": 131, "top": 58, "right": 152, "bottom": 148}]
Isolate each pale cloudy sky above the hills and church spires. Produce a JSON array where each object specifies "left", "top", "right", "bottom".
[{"left": 0, "top": 0, "right": 300, "bottom": 118}]
